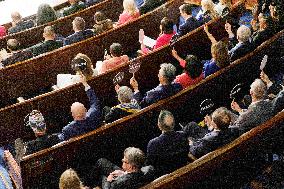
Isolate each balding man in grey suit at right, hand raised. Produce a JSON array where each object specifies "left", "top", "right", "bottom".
[{"left": 231, "top": 79, "right": 273, "bottom": 135}]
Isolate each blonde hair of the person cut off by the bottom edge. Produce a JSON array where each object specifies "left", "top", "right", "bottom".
[{"left": 59, "top": 169, "right": 83, "bottom": 189}]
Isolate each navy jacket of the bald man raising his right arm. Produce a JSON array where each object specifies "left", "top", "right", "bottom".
[{"left": 58, "top": 89, "right": 102, "bottom": 141}]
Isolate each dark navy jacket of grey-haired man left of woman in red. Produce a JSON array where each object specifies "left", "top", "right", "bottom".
[{"left": 133, "top": 83, "right": 182, "bottom": 108}]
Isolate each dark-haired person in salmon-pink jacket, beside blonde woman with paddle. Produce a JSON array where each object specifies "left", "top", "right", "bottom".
[{"left": 97, "top": 43, "right": 129, "bottom": 74}]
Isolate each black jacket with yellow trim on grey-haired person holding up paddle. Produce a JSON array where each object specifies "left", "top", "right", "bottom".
[{"left": 105, "top": 103, "right": 140, "bottom": 123}]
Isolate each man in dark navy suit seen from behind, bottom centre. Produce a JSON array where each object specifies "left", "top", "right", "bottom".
[{"left": 146, "top": 110, "right": 188, "bottom": 176}]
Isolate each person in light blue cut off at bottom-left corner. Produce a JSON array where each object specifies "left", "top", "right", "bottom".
[{"left": 0, "top": 148, "right": 22, "bottom": 189}]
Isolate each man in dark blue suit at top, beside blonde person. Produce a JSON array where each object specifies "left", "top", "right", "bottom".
[{"left": 173, "top": 4, "right": 200, "bottom": 38}]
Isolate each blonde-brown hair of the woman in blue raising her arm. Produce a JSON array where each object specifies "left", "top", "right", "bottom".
[{"left": 211, "top": 41, "right": 230, "bottom": 68}]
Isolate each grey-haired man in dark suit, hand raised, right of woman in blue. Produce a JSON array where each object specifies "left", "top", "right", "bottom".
[{"left": 225, "top": 23, "right": 252, "bottom": 61}]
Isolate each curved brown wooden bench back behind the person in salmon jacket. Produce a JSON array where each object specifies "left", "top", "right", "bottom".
[{"left": 0, "top": 0, "right": 175, "bottom": 106}]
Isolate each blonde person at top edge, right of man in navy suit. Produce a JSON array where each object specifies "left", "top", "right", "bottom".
[{"left": 196, "top": 0, "right": 218, "bottom": 25}]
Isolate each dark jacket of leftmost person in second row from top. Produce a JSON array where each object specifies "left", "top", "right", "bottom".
[{"left": 1, "top": 50, "right": 33, "bottom": 66}]
